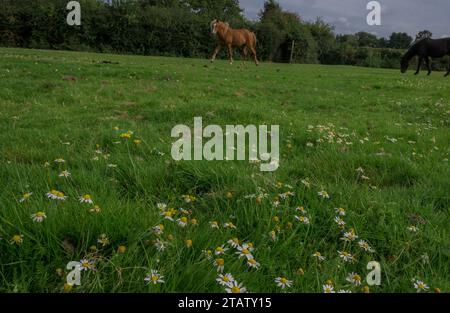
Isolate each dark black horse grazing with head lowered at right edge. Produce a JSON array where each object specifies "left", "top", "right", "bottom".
[{"left": 400, "top": 38, "right": 450, "bottom": 77}]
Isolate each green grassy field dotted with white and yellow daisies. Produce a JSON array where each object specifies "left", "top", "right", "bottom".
[{"left": 0, "top": 49, "right": 450, "bottom": 292}]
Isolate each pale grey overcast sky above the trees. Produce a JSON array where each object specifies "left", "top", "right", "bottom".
[{"left": 240, "top": 0, "right": 450, "bottom": 38}]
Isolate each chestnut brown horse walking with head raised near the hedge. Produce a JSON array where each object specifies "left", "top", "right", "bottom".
[{"left": 211, "top": 20, "right": 259, "bottom": 65}]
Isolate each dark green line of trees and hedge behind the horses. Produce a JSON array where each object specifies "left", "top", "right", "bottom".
[{"left": 0, "top": 0, "right": 445, "bottom": 68}]
